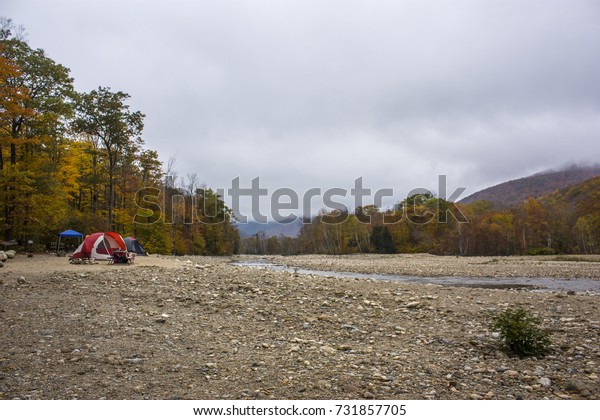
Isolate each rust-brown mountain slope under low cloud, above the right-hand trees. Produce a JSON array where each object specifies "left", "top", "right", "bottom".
[{"left": 460, "top": 165, "right": 600, "bottom": 209}]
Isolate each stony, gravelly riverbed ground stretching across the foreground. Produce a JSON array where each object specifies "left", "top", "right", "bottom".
[{"left": 0, "top": 255, "right": 600, "bottom": 399}]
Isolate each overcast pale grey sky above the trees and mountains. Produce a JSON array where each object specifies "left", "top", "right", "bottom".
[{"left": 0, "top": 0, "right": 600, "bottom": 218}]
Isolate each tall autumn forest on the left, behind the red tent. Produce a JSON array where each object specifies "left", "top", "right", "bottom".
[{"left": 0, "top": 18, "right": 239, "bottom": 255}]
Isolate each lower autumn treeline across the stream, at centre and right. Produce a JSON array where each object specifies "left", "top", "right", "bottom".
[{"left": 241, "top": 177, "right": 600, "bottom": 255}]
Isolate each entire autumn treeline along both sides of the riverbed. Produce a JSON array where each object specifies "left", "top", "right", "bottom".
[{"left": 0, "top": 18, "right": 600, "bottom": 255}]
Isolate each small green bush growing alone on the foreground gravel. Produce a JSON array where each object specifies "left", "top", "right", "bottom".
[{"left": 490, "top": 308, "right": 551, "bottom": 356}]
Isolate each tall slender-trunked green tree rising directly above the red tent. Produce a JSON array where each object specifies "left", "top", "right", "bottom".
[{"left": 73, "top": 87, "right": 145, "bottom": 228}]
